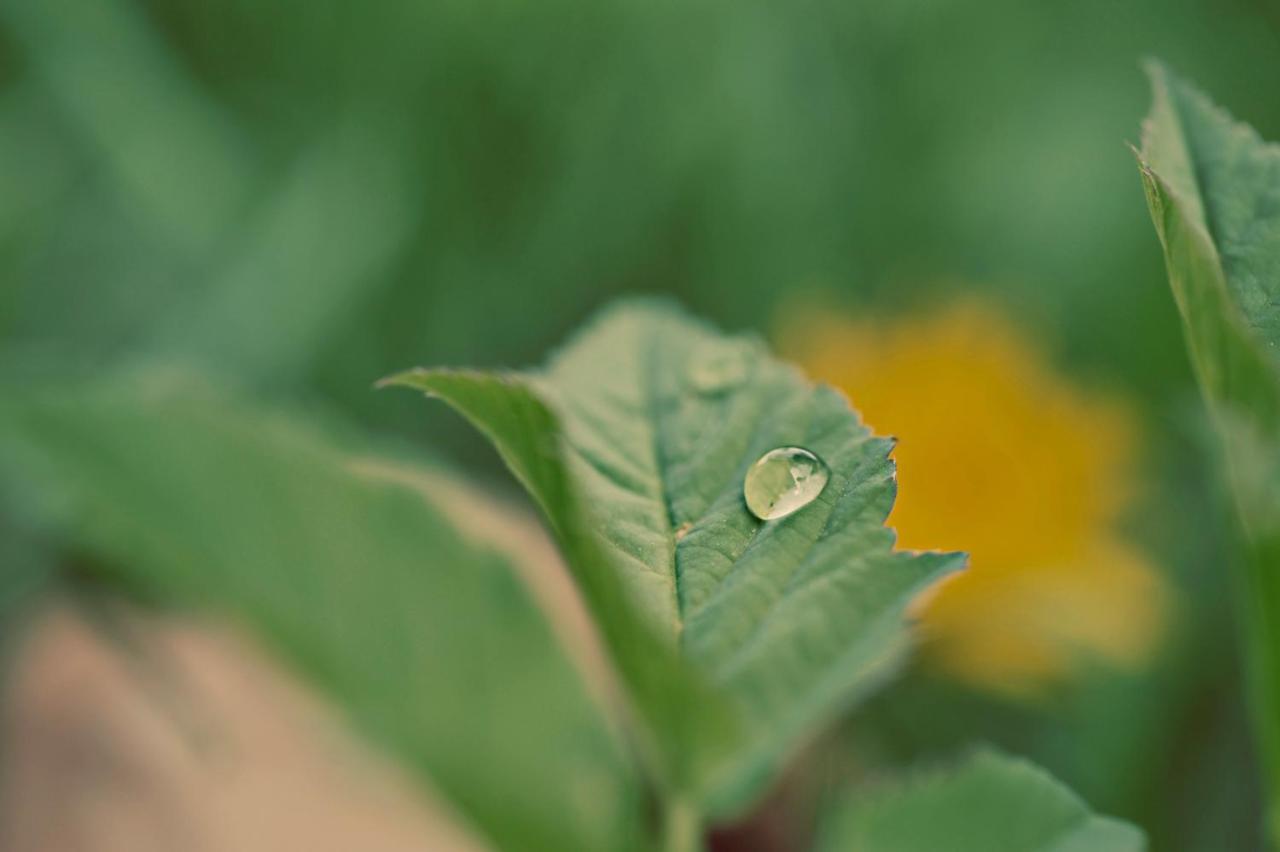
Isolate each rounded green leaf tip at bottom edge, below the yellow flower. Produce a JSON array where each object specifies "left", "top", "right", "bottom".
[{"left": 815, "top": 750, "right": 1147, "bottom": 852}]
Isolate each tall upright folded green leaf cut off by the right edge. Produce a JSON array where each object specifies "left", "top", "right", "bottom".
[{"left": 1138, "top": 64, "right": 1280, "bottom": 842}]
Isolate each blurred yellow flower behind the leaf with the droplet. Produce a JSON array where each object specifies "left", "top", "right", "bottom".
[{"left": 782, "top": 302, "right": 1167, "bottom": 696}]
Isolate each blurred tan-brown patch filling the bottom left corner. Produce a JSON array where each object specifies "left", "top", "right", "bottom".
[{"left": 0, "top": 609, "right": 485, "bottom": 852}]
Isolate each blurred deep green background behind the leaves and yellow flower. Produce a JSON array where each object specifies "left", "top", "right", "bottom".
[{"left": 0, "top": 0, "right": 1280, "bottom": 851}]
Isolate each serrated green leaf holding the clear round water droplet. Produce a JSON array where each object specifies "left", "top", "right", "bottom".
[{"left": 384, "top": 302, "right": 963, "bottom": 815}]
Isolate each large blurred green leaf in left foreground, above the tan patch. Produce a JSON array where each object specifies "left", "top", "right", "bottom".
[{"left": 0, "top": 376, "right": 644, "bottom": 852}]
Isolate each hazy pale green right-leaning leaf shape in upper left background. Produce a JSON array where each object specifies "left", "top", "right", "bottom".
[{"left": 152, "top": 120, "right": 416, "bottom": 386}]
